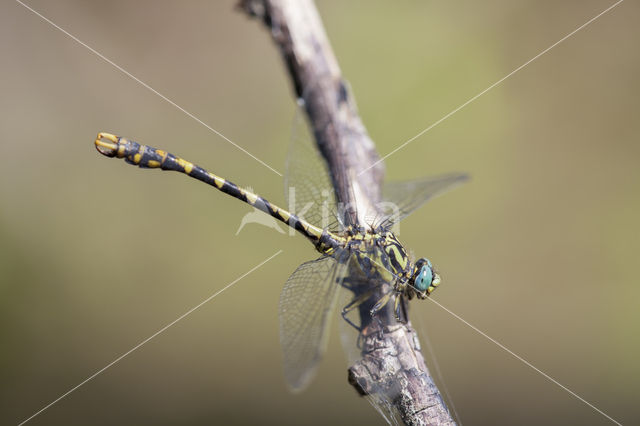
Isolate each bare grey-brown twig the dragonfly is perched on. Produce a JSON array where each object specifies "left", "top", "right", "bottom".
[{"left": 240, "top": 0, "right": 455, "bottom": 425}]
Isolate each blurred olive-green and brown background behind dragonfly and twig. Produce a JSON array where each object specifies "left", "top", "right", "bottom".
[{"left": 0, "top": 0, "right": 640, "bottom": 425}]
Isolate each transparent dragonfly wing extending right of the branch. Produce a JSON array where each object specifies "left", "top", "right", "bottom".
[{"left": 381, "top": 173, "right": 469, "bottom": 229}]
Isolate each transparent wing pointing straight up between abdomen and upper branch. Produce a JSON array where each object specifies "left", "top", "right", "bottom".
[{"left": 284, "top": 101, "right": 340, "bottom": 231}]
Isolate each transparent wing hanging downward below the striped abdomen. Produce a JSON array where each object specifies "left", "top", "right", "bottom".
[{"left": 280, "top": 252, "right": 347, "bottom": 391}]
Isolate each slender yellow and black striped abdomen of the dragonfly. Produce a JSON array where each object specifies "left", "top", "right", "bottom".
[{"left": 95, "top": 133, "right": 339, "bottom": 253}]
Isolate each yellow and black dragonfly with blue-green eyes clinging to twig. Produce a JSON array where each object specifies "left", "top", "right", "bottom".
[{"left": 95, "top": 120, "right": 468, "bottom": 400}]
